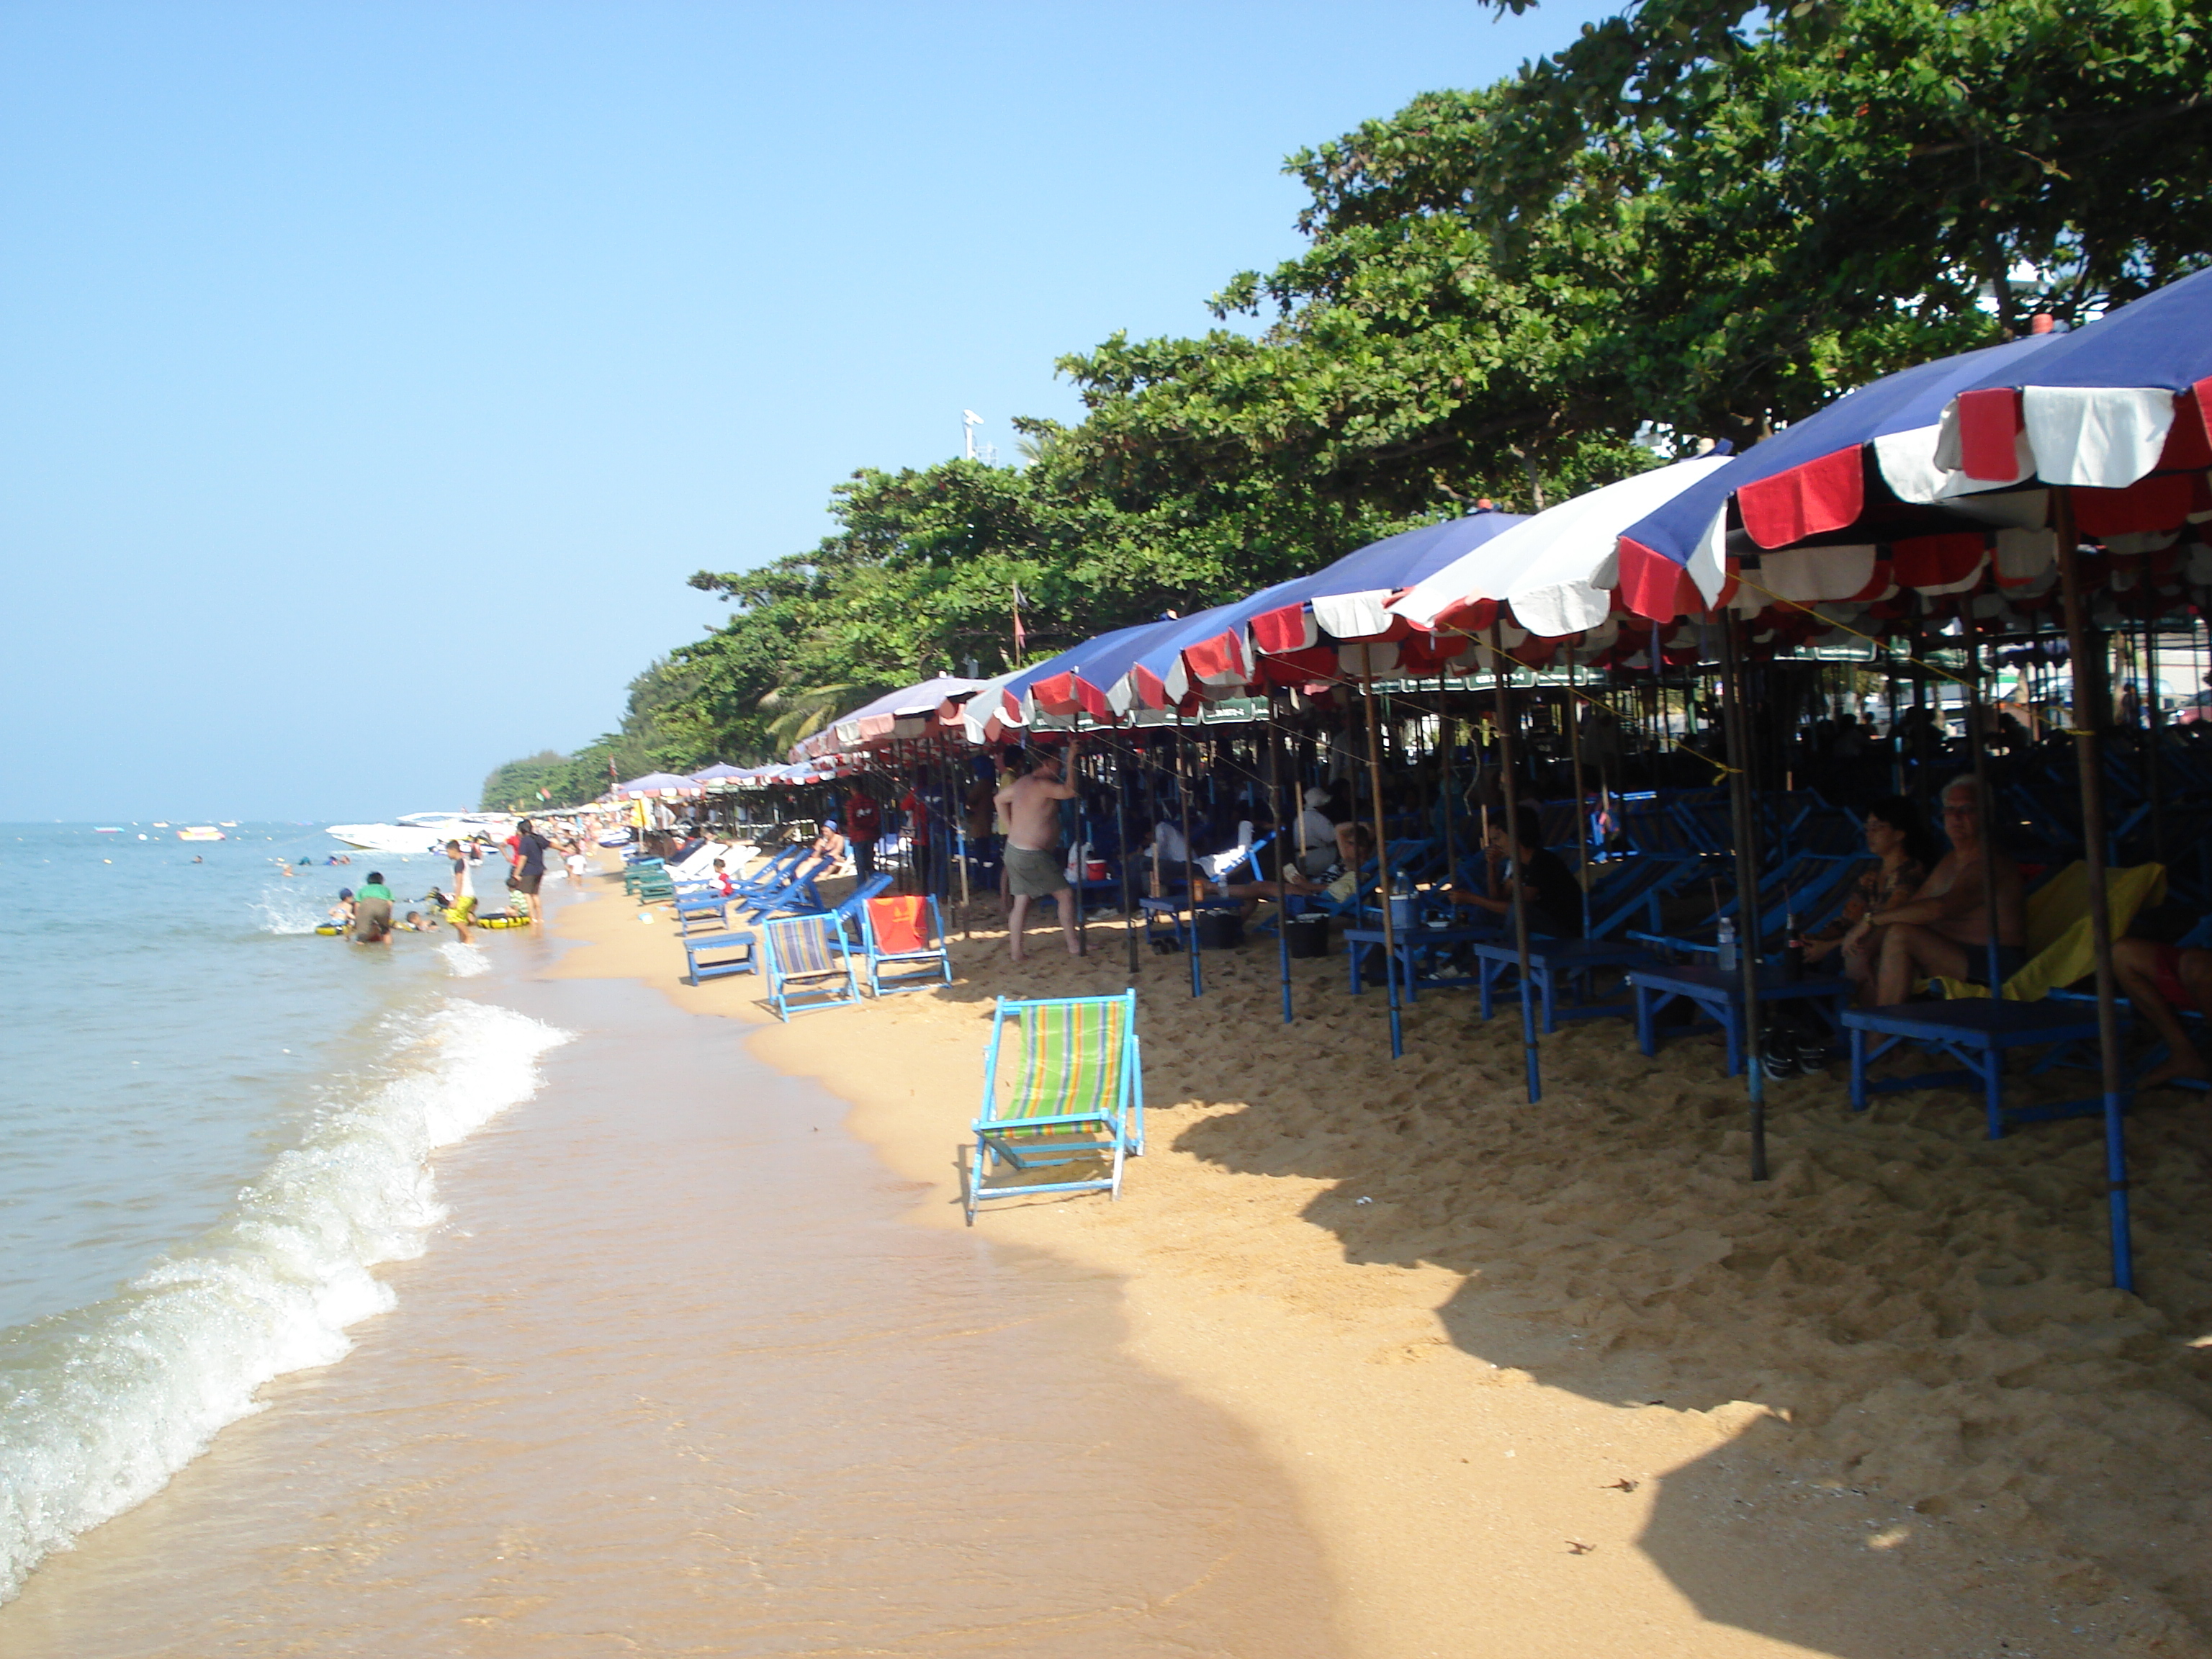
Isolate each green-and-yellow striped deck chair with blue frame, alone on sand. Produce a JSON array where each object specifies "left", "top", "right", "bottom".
[{"left": 966, "top": 991, "right": 1143, "bottom": 1226}]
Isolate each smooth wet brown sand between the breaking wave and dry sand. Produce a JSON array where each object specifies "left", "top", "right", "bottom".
[{"left": 0, "top": 940, "right": 1341, "bottom": 1659}]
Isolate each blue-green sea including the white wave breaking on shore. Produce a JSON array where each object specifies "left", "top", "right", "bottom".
[{"left": 0, "top": 823, "right": 564, "bottom": 1599}]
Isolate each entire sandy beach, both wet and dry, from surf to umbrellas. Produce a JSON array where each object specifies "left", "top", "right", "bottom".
[{"left": 0, "top": 881, "right": 2212, "bottom": 1659}]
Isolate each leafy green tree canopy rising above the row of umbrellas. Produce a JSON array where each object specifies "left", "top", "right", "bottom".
[{"left": 487, "top": 0, "right": 2212, "bottom": 799}]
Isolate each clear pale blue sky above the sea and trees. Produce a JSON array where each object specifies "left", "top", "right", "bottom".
[{"left": 0, "top": 0, "right": 1615, "bottom": 823}]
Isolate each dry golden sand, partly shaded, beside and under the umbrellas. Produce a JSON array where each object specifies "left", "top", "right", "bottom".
[{"left": 559, "top": 871, "right": 2212, "bottom": 1659}]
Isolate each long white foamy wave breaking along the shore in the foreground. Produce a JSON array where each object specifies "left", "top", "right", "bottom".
[{"left": 0, "top": 997, "right": 569, "bottom": 1599}]
